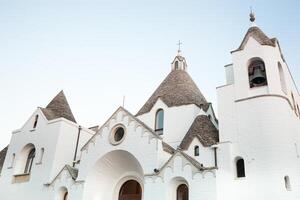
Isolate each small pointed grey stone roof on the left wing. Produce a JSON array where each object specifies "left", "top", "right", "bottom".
[{"left": 42, "top": 91, "right": 76, "bottom": 123}]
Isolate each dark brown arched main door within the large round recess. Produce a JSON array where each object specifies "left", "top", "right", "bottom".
[{"left": 119, "top": 180, "right": 142, "bottom": 200}]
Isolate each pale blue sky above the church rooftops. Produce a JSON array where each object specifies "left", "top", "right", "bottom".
[{"left": 0, "top": 0, "right": 300, "bottom": 148}]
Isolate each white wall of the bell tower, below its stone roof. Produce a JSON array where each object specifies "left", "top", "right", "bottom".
[{"left": 217, "top": 34, "right": 300, "bottom": 200}]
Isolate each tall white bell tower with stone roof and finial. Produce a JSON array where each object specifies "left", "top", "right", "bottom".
[{"left": 217, "top": 12, "right": 300, "bottom": 200}]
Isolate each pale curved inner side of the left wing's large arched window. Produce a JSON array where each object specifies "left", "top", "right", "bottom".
[{"left": 14, "top": 143, "right": 36, "bottom": 174}]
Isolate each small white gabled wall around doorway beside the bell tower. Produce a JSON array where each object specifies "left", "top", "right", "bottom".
[{"left": 145, "top": 156, "right": 216, "bottom": 200}]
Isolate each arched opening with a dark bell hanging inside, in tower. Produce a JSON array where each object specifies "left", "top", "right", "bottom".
[{"left": 248, "top": 58, "right": 268, "bottom": 88}]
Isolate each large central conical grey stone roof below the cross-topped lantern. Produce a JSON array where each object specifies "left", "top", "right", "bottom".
[{"left": 137, "top": 70, "right": 207, "bottom": 115}]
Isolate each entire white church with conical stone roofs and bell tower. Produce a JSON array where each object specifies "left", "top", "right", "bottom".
[{"left": 0, "top": 14, "right": 300, "bottom": 200}]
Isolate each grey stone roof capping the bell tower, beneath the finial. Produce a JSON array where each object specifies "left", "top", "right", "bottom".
[{"left": 235, "top": 26, "right": 276, "bottom": 51}]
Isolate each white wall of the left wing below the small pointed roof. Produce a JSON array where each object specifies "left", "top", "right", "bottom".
[{"left": 0, "top": 109, "right": 87, "bottom": 200}]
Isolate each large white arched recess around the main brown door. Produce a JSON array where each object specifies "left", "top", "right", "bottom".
[{"left": 83, "top": 150, "right": 144, "bottom": 200}]
